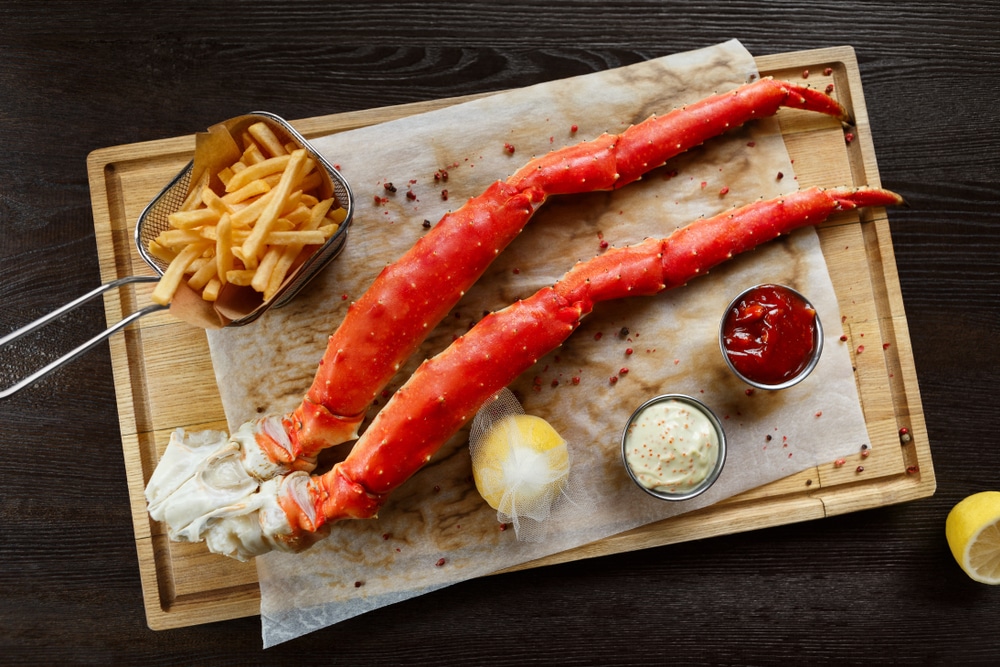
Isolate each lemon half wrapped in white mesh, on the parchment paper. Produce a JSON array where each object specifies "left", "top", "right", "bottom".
[{"left": 472, "top": 414, "right": 569, "bottom": 521}]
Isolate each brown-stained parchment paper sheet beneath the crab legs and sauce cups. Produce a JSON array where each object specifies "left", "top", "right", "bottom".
[{"left": 209, "top": 41, "right": 867, "bottom": 646}]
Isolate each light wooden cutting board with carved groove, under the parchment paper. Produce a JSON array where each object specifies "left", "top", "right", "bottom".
[{"left": 87, "top": 47, "right": 935, "bottom": 630}]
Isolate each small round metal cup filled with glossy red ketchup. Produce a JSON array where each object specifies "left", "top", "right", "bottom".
[{"left": 719, "top": 284, "right": 823, "bottom": 389}]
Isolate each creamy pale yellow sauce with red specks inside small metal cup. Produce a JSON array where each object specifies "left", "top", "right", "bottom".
[{"left": 624, "top": 399, "right": 719, "bottom": 494}]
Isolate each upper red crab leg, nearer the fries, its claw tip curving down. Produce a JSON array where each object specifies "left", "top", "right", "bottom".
[{"left": 256, "top": 78, "right": 849, "bottom": 479}]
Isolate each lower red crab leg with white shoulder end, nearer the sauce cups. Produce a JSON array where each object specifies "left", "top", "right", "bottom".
[{"left": 191, "top": 188, "right": 902, "bottom": 558}]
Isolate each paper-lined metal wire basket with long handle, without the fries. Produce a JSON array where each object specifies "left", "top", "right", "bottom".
[{"left": 0, "top": 111, "right": 354, "bottom": 399}]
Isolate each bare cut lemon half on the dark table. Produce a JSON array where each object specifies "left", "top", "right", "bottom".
[{"left": 945, "top": 491, "right": 1000, "bottom": 585}]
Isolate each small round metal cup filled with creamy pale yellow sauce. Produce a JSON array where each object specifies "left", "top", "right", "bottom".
[{"left": 622, "top": 394, "right": 726, "bottom": 500}]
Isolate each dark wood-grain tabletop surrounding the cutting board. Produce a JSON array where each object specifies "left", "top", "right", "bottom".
[{"left": 0, "top": 0, "right": 1000, "bottom": 665}]
